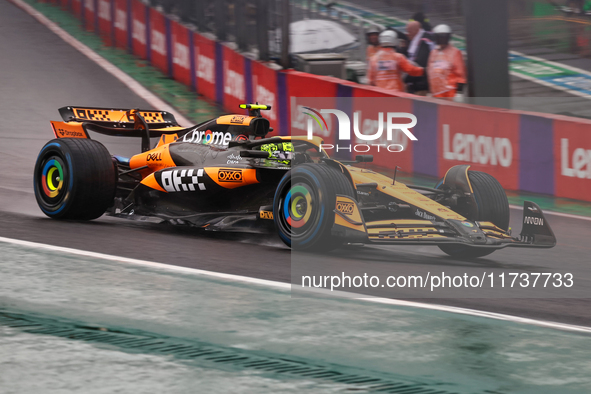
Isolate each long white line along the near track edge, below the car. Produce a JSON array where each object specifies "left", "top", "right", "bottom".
[{"left": 0, "top": 237, "right": 591, "bottom": 334}]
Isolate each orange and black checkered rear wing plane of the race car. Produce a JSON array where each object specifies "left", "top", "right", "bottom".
[{"left": 59, "top": 107, "right": 179, "bottom": 129}]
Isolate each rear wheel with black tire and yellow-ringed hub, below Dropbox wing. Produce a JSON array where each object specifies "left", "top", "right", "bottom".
[{"left": 34, "top": 138, "right": 117, "bottom": 220}]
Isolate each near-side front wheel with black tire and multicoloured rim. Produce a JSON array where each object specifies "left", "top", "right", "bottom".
[{"left": 273, "top": 164, "right": 355, "bottom": 252}]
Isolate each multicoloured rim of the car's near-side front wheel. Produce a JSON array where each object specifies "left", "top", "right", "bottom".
[{"left": 279, "top": 180, "right": 320, "bottom": 242}]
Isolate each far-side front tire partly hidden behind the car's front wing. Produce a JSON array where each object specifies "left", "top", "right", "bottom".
[{"left": 438, "top": 171, "right": 510, "bottom": 259}]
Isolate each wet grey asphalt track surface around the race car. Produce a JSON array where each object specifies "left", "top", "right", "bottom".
[{"left": 0, "top": 0, "right": 591, "bottom": 326}]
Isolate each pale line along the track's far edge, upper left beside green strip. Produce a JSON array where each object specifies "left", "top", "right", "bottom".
[{"left": 8, "top": 0, "right": 193, "bottom": 126}]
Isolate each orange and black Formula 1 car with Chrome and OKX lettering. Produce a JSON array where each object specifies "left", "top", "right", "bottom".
[{"left": 34, "top": 104, "right": 556, "bottom": 258}]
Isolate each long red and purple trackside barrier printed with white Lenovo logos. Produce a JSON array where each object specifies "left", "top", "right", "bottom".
[{"left": 53, "top": 0, "right": 591, "bottom": 201}]
